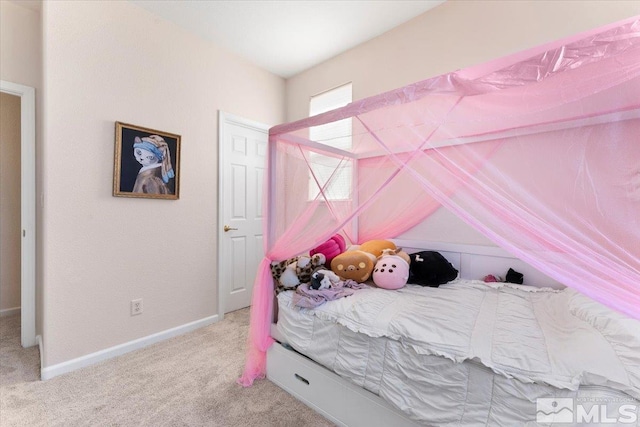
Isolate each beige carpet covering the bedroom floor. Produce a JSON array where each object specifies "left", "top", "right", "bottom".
[{"left": 0, "top": 309, "right": 333, "bottom": 427}]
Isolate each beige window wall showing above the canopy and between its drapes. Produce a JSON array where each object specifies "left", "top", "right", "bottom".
[{"left": 286, "top": 0, "right": 640, "bottom": 244}]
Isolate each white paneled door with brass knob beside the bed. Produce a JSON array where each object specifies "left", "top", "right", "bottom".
[{"left": 218, "top": 111, "right": 269, "bottom": 313}]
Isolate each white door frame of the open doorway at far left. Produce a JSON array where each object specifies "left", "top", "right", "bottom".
[{"left": 0, "top": 80, "right": 36, "bottom": 347}]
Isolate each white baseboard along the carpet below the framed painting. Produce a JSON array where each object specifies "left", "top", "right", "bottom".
[{"left": 41, "top": 314, "right": 219, "bottom": 380}]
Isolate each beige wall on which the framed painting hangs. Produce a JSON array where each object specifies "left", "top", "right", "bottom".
[{"left": 42, "top": 1, "right": 284, "bottom": 367}]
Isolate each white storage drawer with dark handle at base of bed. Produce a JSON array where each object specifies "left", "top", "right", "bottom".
[{"left": 267, "top": 342, "right": 418, "bottom": 427}]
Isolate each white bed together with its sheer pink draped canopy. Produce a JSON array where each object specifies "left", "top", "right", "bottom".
[{"left": 239, "top": 17, "right": 640, "bottom": 426}]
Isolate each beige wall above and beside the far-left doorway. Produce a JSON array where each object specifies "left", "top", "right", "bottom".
[{"left": 0, "top": 0, "right": 43, "bottom": 334}]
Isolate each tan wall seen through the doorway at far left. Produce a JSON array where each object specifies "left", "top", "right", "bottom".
[{"left": 0, "top": 93, "right": 20, "bottom": 310}]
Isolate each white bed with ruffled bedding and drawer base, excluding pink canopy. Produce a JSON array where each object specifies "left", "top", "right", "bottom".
[{"left": 267, "top": 240, "right": 640, "bottom": 426}]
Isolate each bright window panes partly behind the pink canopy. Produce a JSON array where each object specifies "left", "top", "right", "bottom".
[{"left": 309, "top": 83, "right": 353, "bottom": 200}]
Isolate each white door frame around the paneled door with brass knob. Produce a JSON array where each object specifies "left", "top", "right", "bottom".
[{"left": 216, "top": 110, "right": 269, "bottom": 320}]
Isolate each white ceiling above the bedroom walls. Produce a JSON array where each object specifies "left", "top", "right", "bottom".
[{"left": 129, "top": 0, "right": 445, "bottom": 78}]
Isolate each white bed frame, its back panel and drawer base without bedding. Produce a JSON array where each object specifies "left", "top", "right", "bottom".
[{"left": 267, "top": 239, "right": 564, "bottom": 427}]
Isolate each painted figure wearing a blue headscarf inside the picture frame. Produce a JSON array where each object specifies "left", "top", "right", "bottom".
[{"left": 133, "top": 135, "right": 175, "bottom": 194}]
